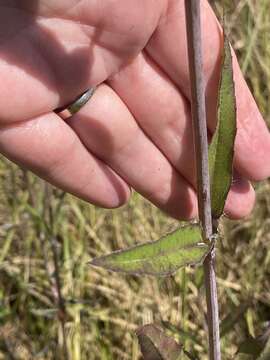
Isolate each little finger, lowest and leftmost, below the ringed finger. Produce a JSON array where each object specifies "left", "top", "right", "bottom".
[{"left": 0, "top": 113, "right": 130, "bottom": 208}]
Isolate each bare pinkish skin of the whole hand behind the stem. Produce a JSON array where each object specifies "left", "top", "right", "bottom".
[{"left": 0, "top": 0, "right": 270, "bottom": 219}]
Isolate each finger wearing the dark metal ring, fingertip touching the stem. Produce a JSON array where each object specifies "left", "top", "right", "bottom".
[{"left": 69, "top": 85, "right": 197, "bottom": 219}]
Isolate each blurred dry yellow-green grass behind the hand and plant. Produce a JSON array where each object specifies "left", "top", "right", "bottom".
[{"left": 0, "top": 0, "right": 270, "bottom": 360}]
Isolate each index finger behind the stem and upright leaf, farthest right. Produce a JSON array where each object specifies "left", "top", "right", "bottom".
[{"left": 147, "top": 0, "right": 270, "bottom": 180}]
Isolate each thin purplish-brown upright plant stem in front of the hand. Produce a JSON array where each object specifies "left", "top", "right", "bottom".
[{"left": 185, "top": 0, "right": 221, "bottom": 360}]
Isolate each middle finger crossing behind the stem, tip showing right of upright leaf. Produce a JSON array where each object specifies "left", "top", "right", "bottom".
[{"left": 110, "top": 53, "right": 254, "bottom": 219}]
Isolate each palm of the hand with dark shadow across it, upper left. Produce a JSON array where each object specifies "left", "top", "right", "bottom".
[{"left": 0, "top": 0, "right": 160, "bottom": 121}]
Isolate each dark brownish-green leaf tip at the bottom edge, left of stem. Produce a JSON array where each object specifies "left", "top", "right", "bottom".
[{"left": 136, "top": 324, "right": 182, "bottom": 360}]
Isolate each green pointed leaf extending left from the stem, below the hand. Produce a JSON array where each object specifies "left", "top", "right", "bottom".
[{"left": 90, "top": 224, "right": 209, "bottom": 276}]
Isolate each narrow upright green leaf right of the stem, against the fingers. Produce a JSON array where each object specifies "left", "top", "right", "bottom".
[{"left": 209, "top": 37, "right": 236, "bottom": 219}]
